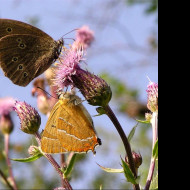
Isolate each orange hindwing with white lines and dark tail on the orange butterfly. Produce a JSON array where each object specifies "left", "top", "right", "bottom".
[{"left": 56, "top": 98, "right": 99, "bottom": 152}]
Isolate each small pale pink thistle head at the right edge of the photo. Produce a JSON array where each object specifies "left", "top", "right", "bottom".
[{"left": 146, "top": 82, "right": 158, "bottom": 112}]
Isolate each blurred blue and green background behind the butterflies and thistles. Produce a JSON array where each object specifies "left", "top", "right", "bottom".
[{"left": 0, "top": 0, "right": 158, "bottom": 189}]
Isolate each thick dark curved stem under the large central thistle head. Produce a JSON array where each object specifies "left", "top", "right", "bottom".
[{"left": 104, "top": 105, "right": 140, "bottom": 190}]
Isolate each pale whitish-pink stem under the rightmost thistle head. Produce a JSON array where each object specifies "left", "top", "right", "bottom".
[{"left": 145, "top": 112, "right": 158, "bottom": 190}]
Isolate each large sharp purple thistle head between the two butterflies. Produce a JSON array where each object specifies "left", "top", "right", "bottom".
[{"left": 55, "top": 45, "right": 112, "bottom": 106}]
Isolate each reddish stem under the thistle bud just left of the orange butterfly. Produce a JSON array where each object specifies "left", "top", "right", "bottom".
[{"left": 35, "top": 133, "right": 72, "bottom": 190}]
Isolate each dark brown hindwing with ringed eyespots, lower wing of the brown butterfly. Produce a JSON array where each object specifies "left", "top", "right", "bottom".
[{"left": 0, "top": 34, "right": 58, "bottom": 86}]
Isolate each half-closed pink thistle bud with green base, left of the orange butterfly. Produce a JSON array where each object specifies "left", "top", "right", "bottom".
[{"left": 13, "top": 101, "right": 41, "bottom": 134}]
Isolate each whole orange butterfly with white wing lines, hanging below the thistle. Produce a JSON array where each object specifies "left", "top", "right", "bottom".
[{"left": 41, "top": 93, "right": 101, "bottom": 154}]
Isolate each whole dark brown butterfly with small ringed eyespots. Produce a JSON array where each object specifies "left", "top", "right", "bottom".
[{"left": 0, "top": 19, "right": 64, "bottom": 86}]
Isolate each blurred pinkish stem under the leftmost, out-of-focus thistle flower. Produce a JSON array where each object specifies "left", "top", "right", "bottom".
[{"left": 4, "top": 134, "right": 17, "bottom": 190}]
